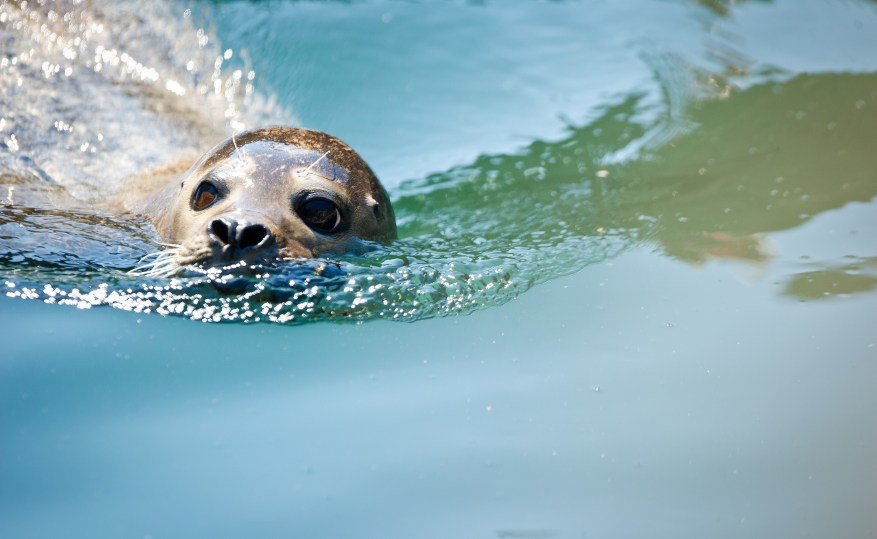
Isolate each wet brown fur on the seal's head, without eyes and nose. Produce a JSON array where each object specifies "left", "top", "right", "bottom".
[{"left": 125, "top": 126, "right": 396, "bottom": 277}]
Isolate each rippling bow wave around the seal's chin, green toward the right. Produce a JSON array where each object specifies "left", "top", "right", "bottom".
[{"left": 0, "top": 98, "right": 644, "bottom": 323}]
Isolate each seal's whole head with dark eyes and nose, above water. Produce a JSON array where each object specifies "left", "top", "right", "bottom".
[{"left": 145, "top": 127, "right": 396, "bottom": 267}]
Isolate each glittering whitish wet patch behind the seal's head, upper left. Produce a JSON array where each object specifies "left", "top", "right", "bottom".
[{"left": 0, "top": 1, "right": 284, "bottom": 207}]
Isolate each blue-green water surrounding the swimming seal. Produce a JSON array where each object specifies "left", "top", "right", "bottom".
[{"left": 0, "top": 0, "right": 877, "bottom": 537}]
